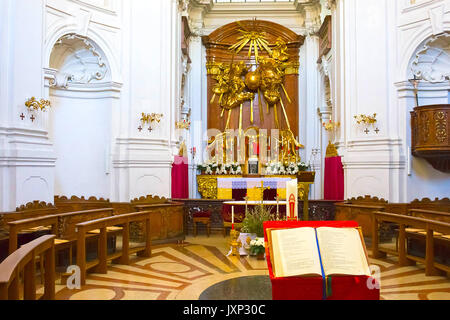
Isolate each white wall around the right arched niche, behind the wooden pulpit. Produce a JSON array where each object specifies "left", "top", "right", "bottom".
[{"left": 395, "top": 0, "right": 450, "bottom": 201}]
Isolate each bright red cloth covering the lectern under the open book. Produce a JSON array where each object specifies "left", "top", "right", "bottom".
[{"left": 264, "top": 221, "right": 380, "bottom": 300}]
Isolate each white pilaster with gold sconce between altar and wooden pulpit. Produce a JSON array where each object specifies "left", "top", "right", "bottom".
[{"left": 334, "top": 0, "right": 405, "bottom": 202}]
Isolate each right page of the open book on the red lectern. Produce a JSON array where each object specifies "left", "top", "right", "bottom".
[{"left": 317, "top": 227, "right": 370, "bottom": 276}]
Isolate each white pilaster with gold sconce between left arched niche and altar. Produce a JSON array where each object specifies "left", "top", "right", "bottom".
[{"left": 114, "top": 0, "right": 181, "bottom": 201}]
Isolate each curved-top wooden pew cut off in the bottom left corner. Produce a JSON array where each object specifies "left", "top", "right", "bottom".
[{"left": 0, "top": 235, "right": 55, "bottom": 300}]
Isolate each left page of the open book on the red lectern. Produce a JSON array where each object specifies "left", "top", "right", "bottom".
[{"left": 271, "top": 228, "right": 322, "bottom": 277}]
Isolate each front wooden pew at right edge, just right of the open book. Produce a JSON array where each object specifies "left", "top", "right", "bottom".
[{"left": 372, "top": 212, "right": 450, "bottom": 276}]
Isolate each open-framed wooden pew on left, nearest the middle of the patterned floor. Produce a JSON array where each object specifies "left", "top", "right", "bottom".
[{"left": 76, "top": 211, "right": 151, "bottom": 285}]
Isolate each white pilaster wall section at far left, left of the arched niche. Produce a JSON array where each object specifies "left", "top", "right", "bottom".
[{"left": 0, "top": 0, "right": 55, "bottom": 211}]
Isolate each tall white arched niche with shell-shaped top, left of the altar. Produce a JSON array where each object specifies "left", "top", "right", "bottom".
[{"left": 47, "top": 33, "right": 114, "bottom": 198}]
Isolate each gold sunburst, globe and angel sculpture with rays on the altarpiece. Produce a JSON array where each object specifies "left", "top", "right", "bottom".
[{"left": 207, "top": 29, "right": 303, "bottom": 148}]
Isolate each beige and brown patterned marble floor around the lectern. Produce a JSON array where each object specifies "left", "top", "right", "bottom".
[{"left": 47, "top": 234, "right": 450, "bottom": 300}]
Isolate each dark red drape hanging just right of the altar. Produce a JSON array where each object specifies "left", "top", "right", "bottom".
[{"left": 324, "top": 157, "right": 344, "bottom": 200}]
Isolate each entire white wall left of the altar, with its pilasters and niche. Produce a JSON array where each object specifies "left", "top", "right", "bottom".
[{"left": 0, "top": 0, "right": 181, "bottom": 211}]
